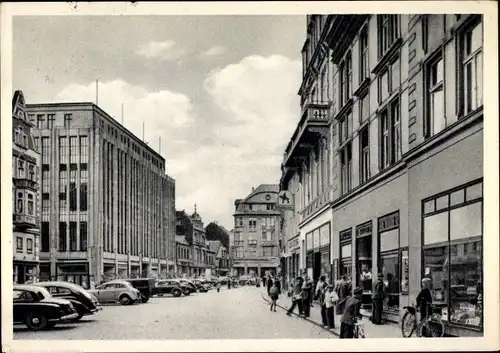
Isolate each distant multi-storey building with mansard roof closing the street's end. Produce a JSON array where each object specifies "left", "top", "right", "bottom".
[{"left": 232, "top": 184, "right": 281, "bottom": 276}]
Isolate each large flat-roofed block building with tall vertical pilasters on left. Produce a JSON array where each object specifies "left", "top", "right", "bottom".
[{"left": 27, "top": 99, "right": 175, "bottom": 287}]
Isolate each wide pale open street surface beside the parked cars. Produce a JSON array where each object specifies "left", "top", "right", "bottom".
[{"left": 14, "top": 287, "right": 336, "bottom": 340}]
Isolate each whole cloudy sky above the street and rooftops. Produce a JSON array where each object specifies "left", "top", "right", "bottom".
[{"left": 13, "top": 16, "right": 306, "bottom": 229}]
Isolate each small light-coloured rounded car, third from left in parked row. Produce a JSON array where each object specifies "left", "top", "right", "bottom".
[{"left": 89, "top": 280, "right": 142, "bottom": 305}]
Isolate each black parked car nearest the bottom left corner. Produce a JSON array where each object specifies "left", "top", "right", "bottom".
[{"left": 12, "top": 285, "right": 78, "bottom": 330}]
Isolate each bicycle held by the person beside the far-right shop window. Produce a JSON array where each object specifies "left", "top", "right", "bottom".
[{"left": 401, "top": 304, "right": 444, "bottom": 338}]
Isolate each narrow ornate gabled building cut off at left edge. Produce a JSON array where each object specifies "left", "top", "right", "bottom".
[{"left": 12, "top": 91, "right": 40, "bottom": 284}]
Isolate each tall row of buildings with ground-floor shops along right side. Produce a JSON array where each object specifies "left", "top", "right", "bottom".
[{"left": 280, "top": 14, "right": 484, "bottom": 336}]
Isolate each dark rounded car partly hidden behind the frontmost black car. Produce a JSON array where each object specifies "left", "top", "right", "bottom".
[{"left": 34, "top": 281, "right": 102, "bottom": 321}]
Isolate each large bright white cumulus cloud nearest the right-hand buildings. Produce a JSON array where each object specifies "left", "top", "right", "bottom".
[{"left": 172, "top": 55, "right": 301, "bottom": 229}]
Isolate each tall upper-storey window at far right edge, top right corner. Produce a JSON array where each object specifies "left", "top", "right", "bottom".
[{"left": 460, "top": 22, "right": 483, "bottom": 115}]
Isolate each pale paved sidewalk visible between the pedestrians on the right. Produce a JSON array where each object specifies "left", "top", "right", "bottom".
[{"left": 261, "top": 291, "right": 403, "bottom": 338}]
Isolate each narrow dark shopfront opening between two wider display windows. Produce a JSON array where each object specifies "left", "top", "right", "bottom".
[{"left": 356, "top": 221, "right": 373, "bottom": 294}]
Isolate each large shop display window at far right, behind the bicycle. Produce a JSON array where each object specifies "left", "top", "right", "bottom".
[{"left": 422, "top": 180, "right": 483, "bottom": 328}]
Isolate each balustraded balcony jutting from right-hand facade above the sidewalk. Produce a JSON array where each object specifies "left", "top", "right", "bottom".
[{"left": 283, "top": 102, "right": 330, "bottom": 169}]
